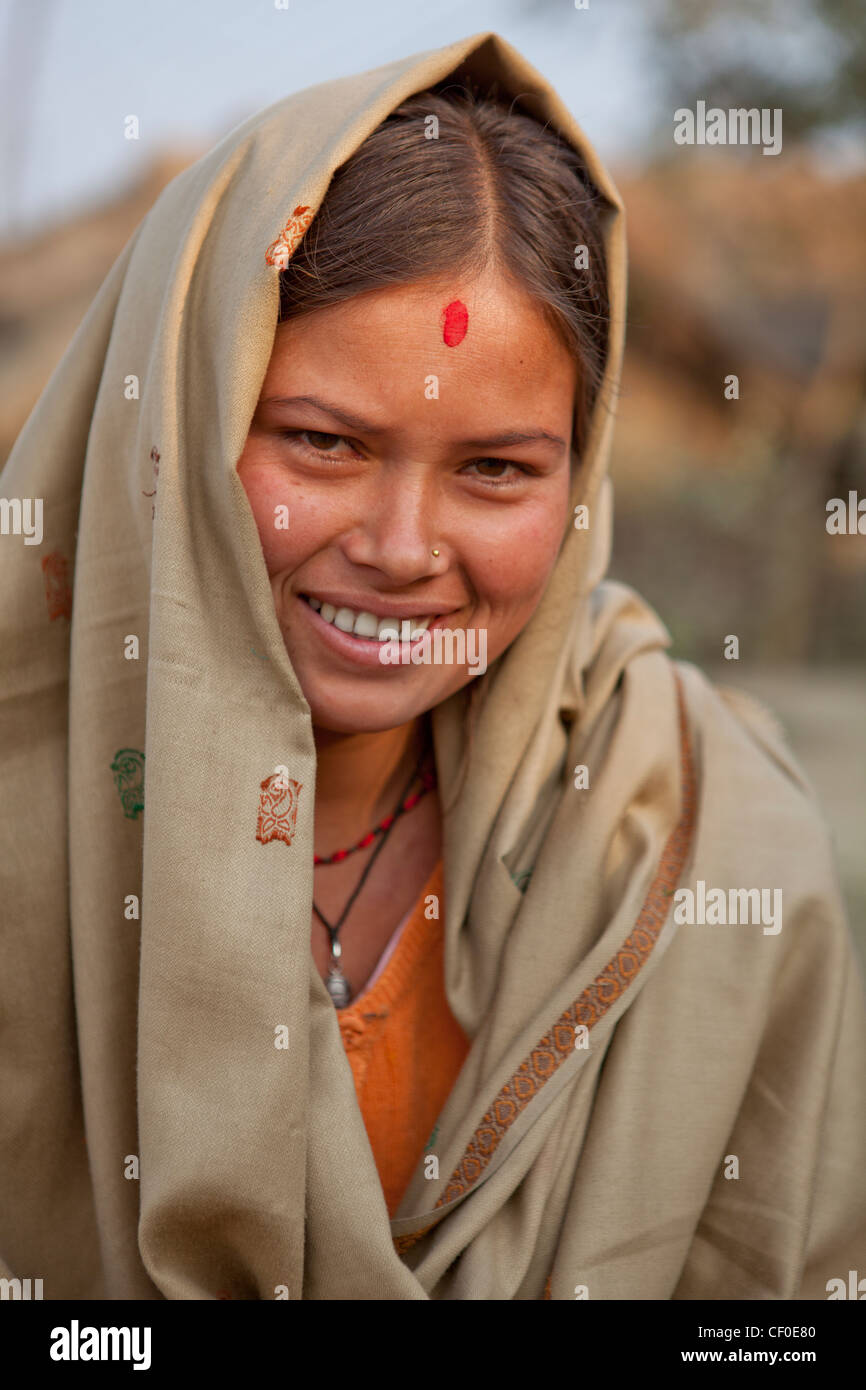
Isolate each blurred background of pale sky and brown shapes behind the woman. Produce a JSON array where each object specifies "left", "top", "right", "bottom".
[{"left": 0, "top": 0, "right": 866, "bottom": 958}]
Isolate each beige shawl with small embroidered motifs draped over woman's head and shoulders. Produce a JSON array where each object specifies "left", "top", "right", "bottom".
[{"left": 0, "top": 33, "right": 866, "bottom": 1300}]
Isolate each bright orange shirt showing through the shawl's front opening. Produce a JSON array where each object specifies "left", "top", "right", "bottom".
[{"left": 336, "top": 860, "right": 470, "bottom": 1216}]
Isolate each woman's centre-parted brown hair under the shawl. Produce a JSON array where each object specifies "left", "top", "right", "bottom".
[{"left": 279, "top": 79, "right": 609, "bottom": 805}]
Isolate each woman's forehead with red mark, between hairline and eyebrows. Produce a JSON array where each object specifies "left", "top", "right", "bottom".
[{"left": 268, "top": 271, "right": 577, "bottom": 406}]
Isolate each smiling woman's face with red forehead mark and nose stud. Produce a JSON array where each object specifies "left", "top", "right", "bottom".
[{"left": 238, "top": 264, "right": 577, "bottom": 733}]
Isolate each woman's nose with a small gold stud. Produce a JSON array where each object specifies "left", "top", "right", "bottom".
[{"left": 343, "top": 467, "right": 448, "bottom": 587}]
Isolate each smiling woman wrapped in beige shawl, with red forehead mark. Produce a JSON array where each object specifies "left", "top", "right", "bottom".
[{"left": 0, "top": 35, "right": 866, "bottom": 1300}]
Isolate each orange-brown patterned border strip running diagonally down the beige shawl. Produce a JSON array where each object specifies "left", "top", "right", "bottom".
[{"left": 395, "top": 670, "right": 696, "bottom": 1255}]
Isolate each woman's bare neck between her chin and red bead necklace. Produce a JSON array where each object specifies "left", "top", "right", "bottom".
[{"left": 313, "top": 717, "right": 425, "bottom": 855}]
